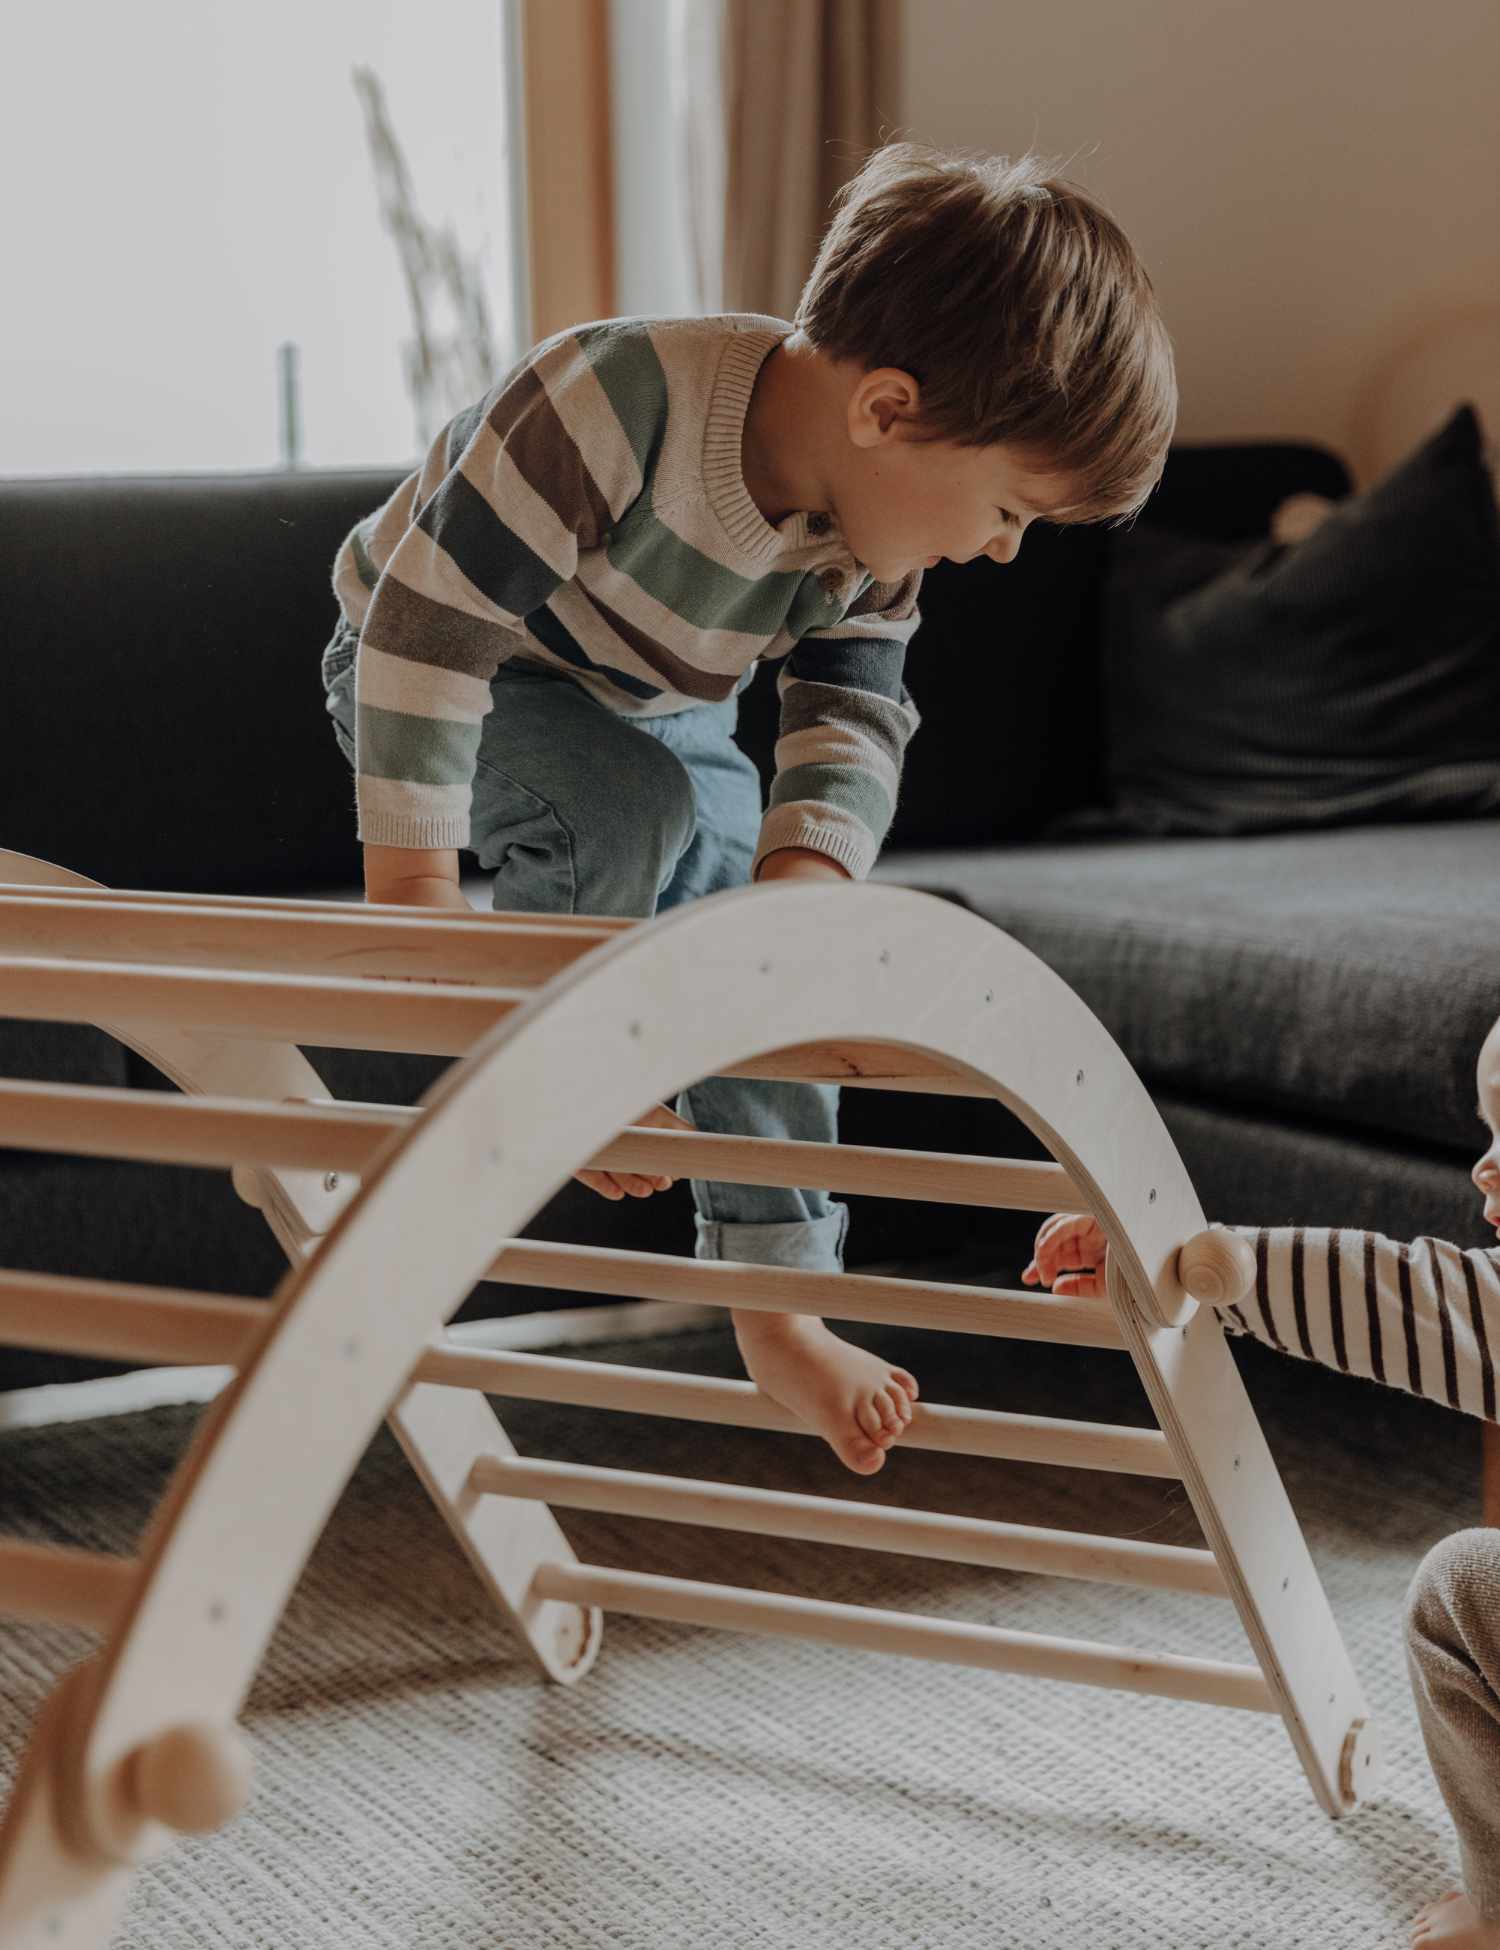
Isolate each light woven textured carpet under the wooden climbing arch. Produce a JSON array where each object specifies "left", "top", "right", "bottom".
[{"left": 0, "top": 1330, "right": 1479, "bottom": 1950}]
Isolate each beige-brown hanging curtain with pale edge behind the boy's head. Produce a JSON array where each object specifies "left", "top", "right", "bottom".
[{"left": 679, "top": 0, "right": 901, "bottom": 318}]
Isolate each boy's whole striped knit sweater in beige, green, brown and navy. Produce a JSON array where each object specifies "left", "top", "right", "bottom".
[{"left": 334, "top": 316, "right": 921, "bottom": 878}]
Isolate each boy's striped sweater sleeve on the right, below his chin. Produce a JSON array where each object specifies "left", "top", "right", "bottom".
[{"left": 755, "top": 573, "right": 921, "bottom": 879}]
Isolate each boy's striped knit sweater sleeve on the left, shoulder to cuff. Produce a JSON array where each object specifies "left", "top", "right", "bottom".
[{"left": 351, "top": 333, "right": 655, "bottom": 848}]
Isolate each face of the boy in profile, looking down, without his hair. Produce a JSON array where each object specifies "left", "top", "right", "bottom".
[{"left": 835, "top": 425, "right": 1075, "bottom": 583}]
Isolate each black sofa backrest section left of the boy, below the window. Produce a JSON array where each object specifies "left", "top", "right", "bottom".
[{"left": 0, "top": 472, "right": 400, "bottom": 893}]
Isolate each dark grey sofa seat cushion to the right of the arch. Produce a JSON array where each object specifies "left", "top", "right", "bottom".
[{"left": 876, "top": 819, "right": 1500, "bottom": 1154}]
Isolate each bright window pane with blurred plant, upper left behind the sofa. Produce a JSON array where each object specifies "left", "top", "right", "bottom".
[{"left": 0, "top": 0, "right": 521, "bottom": 474}]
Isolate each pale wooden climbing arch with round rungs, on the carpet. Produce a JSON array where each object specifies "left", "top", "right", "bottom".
[{"left": 0, "top": 852, "right": 1377, "bottom": 1950}]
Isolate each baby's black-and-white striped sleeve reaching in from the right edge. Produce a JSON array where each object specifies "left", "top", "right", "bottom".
[{"left": 1223, "top": 1227, "right": 1500, "bottom": 1422}]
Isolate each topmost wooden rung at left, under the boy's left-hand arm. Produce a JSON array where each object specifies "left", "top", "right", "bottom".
[{"left": 0, "top": 893, "right": 618, "bottom": 987}]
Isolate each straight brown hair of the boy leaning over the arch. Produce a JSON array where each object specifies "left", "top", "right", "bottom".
[{"left": 796, "top": 142, "right": 1176, "bottom": 521}]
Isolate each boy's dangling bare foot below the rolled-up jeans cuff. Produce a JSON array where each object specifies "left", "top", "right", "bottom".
[{"left": 731, "top": 1308, "right": 917, "bottom": 1476}]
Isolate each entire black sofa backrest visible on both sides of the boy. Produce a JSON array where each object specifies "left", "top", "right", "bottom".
[{"left": 0, "top": 445, "right": 1348, "bottom": 893}]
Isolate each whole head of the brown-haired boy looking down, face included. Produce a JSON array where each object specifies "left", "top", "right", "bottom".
[{"left": 796, "top": 142, "right": 1176, "bottom": 581}]
